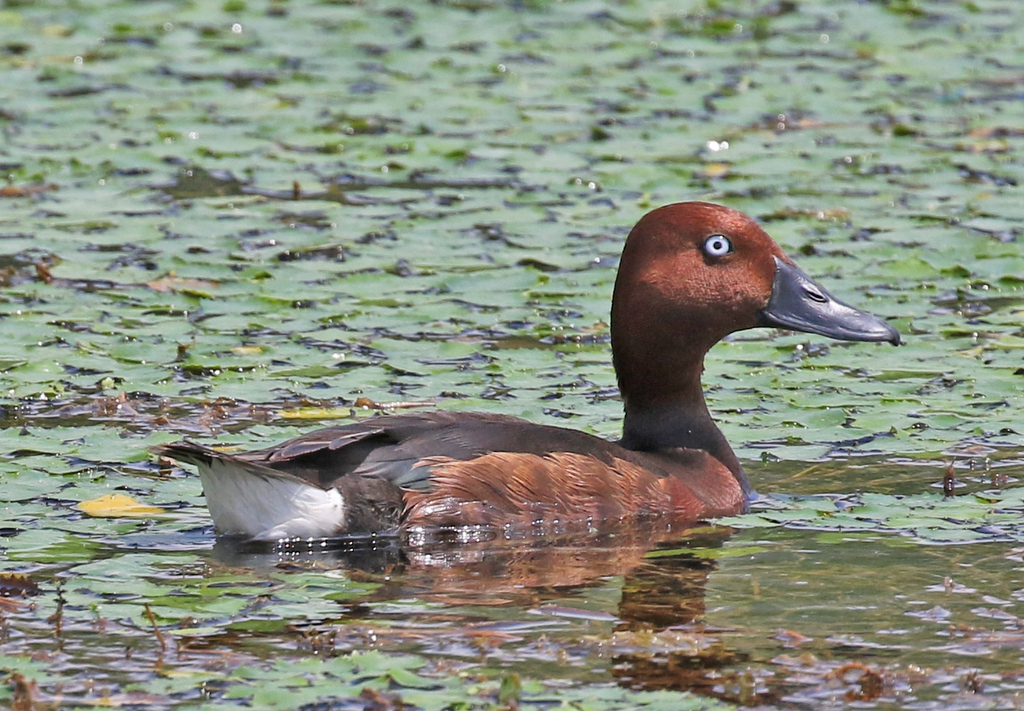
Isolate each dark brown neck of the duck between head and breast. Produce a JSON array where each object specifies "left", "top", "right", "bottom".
[{"left": 620, "top": 360, "right": 753, "bottom": 494}]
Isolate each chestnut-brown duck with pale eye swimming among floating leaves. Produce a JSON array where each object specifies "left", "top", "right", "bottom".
[{"left": 152, "top": 202, "right": 901, "bottom": 541}]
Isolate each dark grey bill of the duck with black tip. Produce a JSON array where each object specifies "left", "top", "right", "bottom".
[{"left": 761, "top": 257, "right": 901, "bottom": 345}]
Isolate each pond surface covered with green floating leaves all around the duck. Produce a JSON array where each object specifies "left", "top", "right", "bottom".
[{"left": 0, "top": 0, "right": 1024, "bottom": 709}]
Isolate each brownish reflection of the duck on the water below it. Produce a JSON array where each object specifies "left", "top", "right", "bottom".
[{"left": 213, "top": 519, "right": 766, "bottom": 703}]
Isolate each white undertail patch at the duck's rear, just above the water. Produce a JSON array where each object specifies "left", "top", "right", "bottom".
[{"left": 199, "top": 459, "right": 345, "bottom": 541}]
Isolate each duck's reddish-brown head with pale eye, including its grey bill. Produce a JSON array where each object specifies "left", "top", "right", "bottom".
[{"left": 611, "top": 203, "right": 900, "bottom": 407}]
